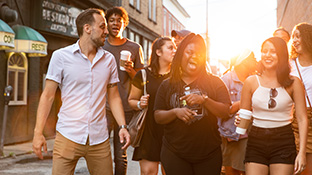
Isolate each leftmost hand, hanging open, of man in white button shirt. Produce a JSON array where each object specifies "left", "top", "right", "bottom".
[{"left": 32, "top": 132, "right": 48, "bottom": 159}]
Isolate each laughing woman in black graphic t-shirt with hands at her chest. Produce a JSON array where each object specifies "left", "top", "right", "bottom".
[{"left": 154, "top": 33, "right": 231, "bottom": 175}]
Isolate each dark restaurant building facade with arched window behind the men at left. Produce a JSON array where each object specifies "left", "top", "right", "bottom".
[{"left": 0, "top": 0, "right": 163, "bottom": 144}]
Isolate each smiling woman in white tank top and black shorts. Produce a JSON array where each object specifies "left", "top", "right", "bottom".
[{"left": 236, "top": 37, "right": 308, "bottom": 175}]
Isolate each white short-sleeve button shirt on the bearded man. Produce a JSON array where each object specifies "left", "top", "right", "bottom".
[{"left": 46, "top": 41, "right": 119, "bottom": 145}]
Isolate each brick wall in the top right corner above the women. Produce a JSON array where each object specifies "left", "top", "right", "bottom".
[{"left": 277, "top": 0, "right": 312, "bottom": 33}]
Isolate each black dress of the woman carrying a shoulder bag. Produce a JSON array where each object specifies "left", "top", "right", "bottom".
[{"left": 132, "top": 68, "right": 169, "bottom": 161}]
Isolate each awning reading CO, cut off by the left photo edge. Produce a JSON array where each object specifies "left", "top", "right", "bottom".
[{"left": 0, "top": 19, "right": 15, "bottom": 50}]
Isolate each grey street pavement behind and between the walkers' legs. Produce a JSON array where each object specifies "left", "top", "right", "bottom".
[{"left": 0, "top": 139, "right": 157, "bottom": 175}]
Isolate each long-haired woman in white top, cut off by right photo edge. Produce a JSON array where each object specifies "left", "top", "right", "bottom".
[{"left": 290, "top": 23, "right": 312, "bottom": 175}]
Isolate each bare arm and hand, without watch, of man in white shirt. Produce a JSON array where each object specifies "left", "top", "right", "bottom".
[{"left": 32, "top": 80, "right": 58, "bottom": 159}]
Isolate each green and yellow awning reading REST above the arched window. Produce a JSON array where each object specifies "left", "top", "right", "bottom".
[{"left": 10, "top": 25, "right": 48, "bottom": 57}]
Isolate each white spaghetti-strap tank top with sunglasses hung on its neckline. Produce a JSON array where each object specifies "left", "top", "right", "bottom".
[{"left": 251, "top": 75, "right": 293, "bottom": 128}]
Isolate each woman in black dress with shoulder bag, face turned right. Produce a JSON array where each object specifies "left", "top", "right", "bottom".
[{"left": 128, "top": 37, "right": 176, "bottom": 175}]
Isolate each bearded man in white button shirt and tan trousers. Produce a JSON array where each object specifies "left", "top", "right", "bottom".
[{"left": 33, "top": 9, "right": 130, "bottom": 175}]
